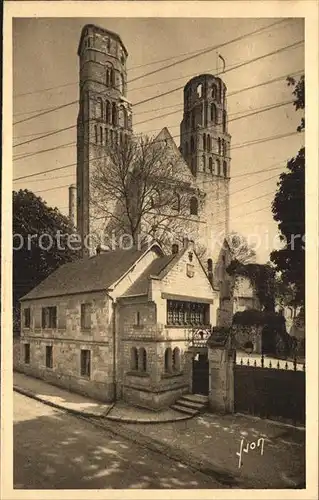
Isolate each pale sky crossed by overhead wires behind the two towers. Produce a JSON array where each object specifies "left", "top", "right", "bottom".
[{"left": 13, "top": 18, "right": 304, "bottom": 262}]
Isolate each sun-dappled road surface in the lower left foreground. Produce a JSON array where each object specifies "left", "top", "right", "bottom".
[{"left": 14, "top": 393, "right": 221, "bottom": 489}]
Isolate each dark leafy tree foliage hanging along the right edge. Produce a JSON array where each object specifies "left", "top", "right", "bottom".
[{"left": 271, "top": 76, "right": 305, "bottom": 305}]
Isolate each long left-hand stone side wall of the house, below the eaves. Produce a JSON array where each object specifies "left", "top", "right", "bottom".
[{"left": 15, "top": 293, "right": 114, "bottom": 401}]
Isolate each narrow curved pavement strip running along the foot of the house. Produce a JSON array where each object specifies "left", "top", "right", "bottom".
[{"left": 13, "top": 372, "right": 190, "bottom": 424}]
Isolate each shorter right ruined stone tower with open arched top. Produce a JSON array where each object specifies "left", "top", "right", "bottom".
[{"left": 181, "top": 74, "right": 231, "bottom": 257}]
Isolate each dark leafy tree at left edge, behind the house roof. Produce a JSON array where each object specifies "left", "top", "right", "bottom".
[{"left": 13, "top": 189, "right": 80, "bottom": 329}]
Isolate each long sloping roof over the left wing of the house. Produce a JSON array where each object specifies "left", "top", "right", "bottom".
[{"left": 21, "top": 249, "right": 145, "bottom": 300}]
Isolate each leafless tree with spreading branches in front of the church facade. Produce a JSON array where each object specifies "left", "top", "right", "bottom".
[{"left": 90, "top": 136, "right": 201, "bottom": 250}]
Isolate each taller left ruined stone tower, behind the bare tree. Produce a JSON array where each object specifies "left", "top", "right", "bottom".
[{"left": 77, "top": 24, "right": 132, "bottom": 254}]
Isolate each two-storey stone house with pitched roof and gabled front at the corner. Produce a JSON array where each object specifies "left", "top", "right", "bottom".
[{"left": 17, "top": 243, "right": 219, "bottom": 410}]
